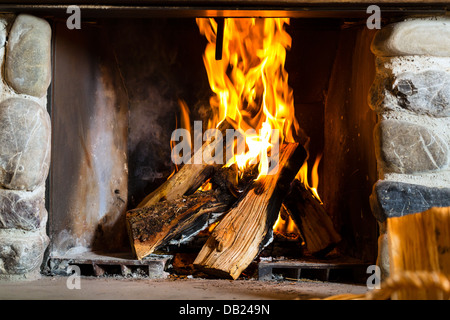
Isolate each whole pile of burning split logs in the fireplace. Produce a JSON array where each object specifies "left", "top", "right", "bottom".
[{"left": 126, "top": 121, "right": 340, "bottom": 279}]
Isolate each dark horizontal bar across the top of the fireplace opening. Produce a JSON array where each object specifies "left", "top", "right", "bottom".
[{"left": 0, "top": 4, "right": 444, "bottom": 19}]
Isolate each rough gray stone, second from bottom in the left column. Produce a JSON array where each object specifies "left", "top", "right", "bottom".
[{"left": 0, "top": 185, "right": 48, "bottom": 231}]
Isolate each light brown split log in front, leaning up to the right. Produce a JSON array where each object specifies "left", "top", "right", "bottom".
[{"left": 194, "top": 143, "right": 307, "bottom": 279}]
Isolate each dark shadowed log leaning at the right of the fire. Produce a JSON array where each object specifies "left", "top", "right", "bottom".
[{"left": 283, "top": 179, "right": 341, "bottom": 256}]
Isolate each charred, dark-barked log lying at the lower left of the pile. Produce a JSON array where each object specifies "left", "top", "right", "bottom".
[{"left": 126, "top": 189, "right": 235, "bottom": 260}]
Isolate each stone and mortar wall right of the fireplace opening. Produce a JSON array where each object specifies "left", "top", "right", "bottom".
[{"left": 369, "top": 17, "right": 450, "bottom": 275}]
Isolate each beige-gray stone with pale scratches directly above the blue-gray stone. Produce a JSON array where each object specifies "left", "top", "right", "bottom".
[{"left": 374, "top": 119, "right": 449, "bottom": 174}]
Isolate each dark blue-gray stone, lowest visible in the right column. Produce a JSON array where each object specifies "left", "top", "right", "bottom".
[{"left": 370, "top": 180, "right": 450, "bottom": 222}]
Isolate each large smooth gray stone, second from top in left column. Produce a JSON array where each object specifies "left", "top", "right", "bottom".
[{"left": 0, "top": 98, "right": 51, "bottom": 190}]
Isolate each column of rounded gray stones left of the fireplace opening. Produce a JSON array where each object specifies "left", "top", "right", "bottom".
[{"left": 0, "top": 14, "right": 51, "bottom": 279}]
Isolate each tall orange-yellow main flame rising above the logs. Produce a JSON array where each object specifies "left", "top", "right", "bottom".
[{"left": 197, "top": 18, "right": 299, "bottom": 179}]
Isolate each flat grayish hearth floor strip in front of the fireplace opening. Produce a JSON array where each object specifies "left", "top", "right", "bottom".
[{"left": 0, "top": 276, "right": 367, "bottom": 300}]
